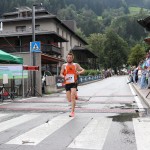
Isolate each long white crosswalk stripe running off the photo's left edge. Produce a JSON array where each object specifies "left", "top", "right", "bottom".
[{"left": 0, "top": 115, "right": 39, "bottom": 132}]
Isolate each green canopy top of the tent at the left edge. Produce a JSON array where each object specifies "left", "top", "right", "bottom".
[{"left": 0, "top": 50, "right": 23, "bottom": 64}]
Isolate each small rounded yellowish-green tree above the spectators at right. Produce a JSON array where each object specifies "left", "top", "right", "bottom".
[{"left": 128, "top": 44, "right": 146, "bottom": 66}]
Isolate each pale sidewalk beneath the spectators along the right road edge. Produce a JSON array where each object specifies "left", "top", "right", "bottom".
[{"left": 131, "top": 83, "right": 150, "bottom": 107}]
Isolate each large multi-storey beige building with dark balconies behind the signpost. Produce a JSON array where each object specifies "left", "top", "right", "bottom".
[{"left": 0, "top": 7, "right": 95, "bottom": 94}]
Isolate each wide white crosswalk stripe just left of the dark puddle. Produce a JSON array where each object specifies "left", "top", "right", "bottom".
[{"left": 68, "top": 118, "right": 112, "bottom": 150}]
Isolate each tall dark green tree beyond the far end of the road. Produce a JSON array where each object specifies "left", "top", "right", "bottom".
[{"left": 104, "top": 29, "right": 128, "bottom": 73}]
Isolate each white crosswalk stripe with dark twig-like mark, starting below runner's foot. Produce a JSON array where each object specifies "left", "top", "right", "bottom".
[{"left": 6, "top": 115, "right": 73, "bottom": 145}]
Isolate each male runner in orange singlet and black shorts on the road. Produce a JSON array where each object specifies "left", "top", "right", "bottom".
[{"left": 60, "top": 53, "right": 85, "bottom": 117}]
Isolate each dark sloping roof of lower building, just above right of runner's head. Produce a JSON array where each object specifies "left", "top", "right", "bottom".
[{"left": 71, "top": 46, "right": 98, "bottom": 58}]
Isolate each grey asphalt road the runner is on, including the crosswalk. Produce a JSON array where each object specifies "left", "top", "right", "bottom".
[{"left": 0, "top": 76, "right": 150, "bottom": 150}]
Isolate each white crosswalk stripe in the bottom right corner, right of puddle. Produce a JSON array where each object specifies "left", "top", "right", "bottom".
[{"left": 133, "top": 118, "right": 150, "bottom": 150}]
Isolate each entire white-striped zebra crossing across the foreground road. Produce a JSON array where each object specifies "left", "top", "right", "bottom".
[{"left": 0, "top": 112, "right": 150, "bottom": 150}]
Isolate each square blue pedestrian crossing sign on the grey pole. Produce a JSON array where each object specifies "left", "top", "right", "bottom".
[{"left": 30, "top": 41, "right": 41, "bottom": 53}]
